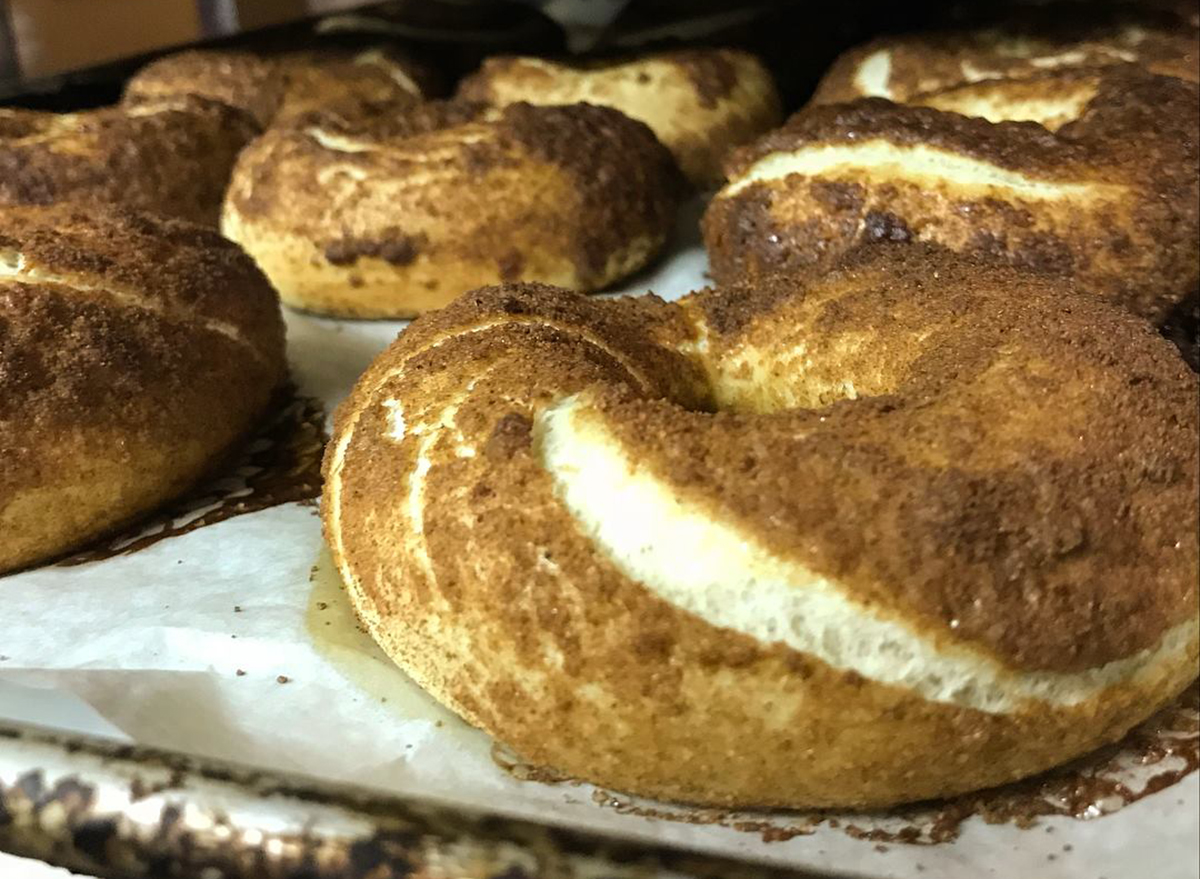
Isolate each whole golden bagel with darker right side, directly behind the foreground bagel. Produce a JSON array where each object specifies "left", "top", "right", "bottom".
[{"left": 222, "top": 102, "right": 682, "bottom": 317}]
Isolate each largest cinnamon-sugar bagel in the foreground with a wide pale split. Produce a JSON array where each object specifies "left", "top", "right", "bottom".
[{"left": 323, "top": 247, "right": 1200, "bottom": 807}]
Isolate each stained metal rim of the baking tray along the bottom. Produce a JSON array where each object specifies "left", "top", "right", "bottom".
[{"left": 0, "top": 722, "right": 817, "bottom": 879}]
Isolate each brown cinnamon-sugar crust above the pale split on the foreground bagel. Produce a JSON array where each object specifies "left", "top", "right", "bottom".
[{"left": 648, "top": 245, "right": 1200, "bottom": 671}]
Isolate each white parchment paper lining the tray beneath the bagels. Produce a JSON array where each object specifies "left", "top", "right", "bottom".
[{"left": 0, "top": 203, "right": 1200, "bottom": 879}]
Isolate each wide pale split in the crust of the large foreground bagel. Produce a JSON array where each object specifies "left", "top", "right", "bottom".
[{"left": 538, "top": 397, "right": 1196, "bottom": 713}]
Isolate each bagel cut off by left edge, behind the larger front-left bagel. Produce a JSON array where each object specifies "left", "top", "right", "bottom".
[{"left": 0, "top": 98, "right": 258, "bottom": 226}]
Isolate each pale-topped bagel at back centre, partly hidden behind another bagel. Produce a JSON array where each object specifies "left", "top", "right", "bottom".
[{"left": 458, "top": 49, "right": 782, "bottom": 187}]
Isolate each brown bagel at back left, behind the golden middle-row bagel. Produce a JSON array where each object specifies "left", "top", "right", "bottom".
[{"left": 124, "top": 47, "right": 436, "bottom": 127}]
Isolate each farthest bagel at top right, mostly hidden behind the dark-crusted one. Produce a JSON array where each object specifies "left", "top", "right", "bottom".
[{"left": 812, "top": 5, "right": 1200, "bottom": 103}]
